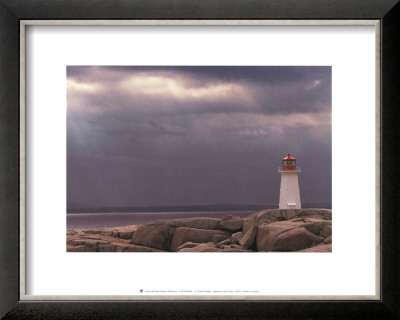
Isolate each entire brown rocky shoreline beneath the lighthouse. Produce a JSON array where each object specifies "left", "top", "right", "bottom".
[{"left": 67, "top": 209, "right": 332, "bottom": 252}]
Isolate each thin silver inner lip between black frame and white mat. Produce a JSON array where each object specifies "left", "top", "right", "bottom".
[{"left": 20, "top": 20, "right": 380, "bottom": 301}]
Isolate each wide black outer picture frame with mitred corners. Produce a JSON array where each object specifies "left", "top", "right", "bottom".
[{"left": 0, "top": 0, "right": 400, "bottom": 319}]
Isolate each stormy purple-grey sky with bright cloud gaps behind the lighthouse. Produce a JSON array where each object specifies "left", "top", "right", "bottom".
[{"left": 67, "top": 66, "right": 332, "bottom": 207}]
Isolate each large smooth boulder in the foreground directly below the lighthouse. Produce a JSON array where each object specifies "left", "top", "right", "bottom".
[{"left": 257, "top": 221, "right": 324, "bottom": 251}]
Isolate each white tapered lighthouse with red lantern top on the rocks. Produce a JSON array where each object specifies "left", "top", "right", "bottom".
[{"left": 278, "top": 153, "right": 301, "bottom": 209}]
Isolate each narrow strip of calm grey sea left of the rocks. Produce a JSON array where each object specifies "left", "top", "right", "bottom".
[{"left": 67, "top": 211, "right": 256, "bottom": 229}]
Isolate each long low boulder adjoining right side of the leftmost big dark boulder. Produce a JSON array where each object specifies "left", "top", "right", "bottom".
[{"left": 170, "top": 227, "right": 231, "bottom": 251}]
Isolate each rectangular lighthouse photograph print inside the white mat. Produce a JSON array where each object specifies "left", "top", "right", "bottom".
[{"left": 66, "top": 66, "right": 332, "bottom": 254}]
